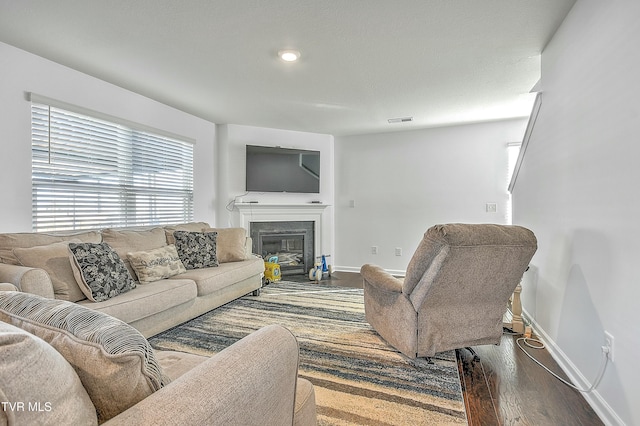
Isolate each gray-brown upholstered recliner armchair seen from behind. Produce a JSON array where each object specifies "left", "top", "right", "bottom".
[{"left": 360, "top": 224, "right": 537, "bottom": 358}]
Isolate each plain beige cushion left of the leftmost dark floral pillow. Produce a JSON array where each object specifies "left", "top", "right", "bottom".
[{"left": 13, "top": 238, "right": 86, "bottom": 302}]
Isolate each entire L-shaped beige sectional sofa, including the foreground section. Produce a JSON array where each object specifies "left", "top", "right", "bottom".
[{"left": 0, "top": 222, "right": 316, "bottom": 426}]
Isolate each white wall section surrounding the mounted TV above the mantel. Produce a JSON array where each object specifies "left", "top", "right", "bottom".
[{"left": 216, "top": 124, "right": 334, "bottom": 254}]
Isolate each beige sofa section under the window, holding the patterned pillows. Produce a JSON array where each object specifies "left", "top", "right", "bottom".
[{"left": 0, "top": 222, "right": 264, "bottom": 337}]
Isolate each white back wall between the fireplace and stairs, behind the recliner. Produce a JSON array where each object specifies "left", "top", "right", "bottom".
[{"left": 335, "top": 119, "right": 527, "bottom": 273}]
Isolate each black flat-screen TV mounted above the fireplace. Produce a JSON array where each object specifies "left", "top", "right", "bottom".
[{"left": 246, "top": 145, "right": 320, "bottom": 194}]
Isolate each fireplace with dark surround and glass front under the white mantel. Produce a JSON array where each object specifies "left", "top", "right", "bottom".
[{"left": 249, "top": 221, "right": 315, "bottom": 275}]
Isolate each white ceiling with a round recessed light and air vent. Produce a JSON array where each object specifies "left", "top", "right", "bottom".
[{"left": 0, "top": 0, "right": 575, "bottom": 135}]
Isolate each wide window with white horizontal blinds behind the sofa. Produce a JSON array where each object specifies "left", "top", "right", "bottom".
[{"left": 31, "top": 96, "right": 193, "bottom": 231}]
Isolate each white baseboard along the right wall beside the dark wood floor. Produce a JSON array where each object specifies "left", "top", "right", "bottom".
[{"left": 522, "top": 308, "right": 625, "bottom": 426}]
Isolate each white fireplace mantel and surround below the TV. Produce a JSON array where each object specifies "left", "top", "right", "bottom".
[{"left": 235, "top": 203, "right": 329, "bottom": 262}]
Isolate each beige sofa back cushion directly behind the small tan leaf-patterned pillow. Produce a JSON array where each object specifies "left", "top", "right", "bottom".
[{"left": 102, "top": 227, "right": 167, "bottom": 279}]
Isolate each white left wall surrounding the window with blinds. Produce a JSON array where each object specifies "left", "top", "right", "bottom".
[{"left": 0, "top": 43, "right": 216, "bottom": 232}]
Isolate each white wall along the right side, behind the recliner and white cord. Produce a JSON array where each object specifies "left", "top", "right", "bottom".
[{"left": 514, "top": 0, "right": 640, "bottom": 425}]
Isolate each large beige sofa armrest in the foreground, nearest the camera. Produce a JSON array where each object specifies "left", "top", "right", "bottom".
[{"left": 104, "top": 325, "right": 298, "bottom": 426}]
